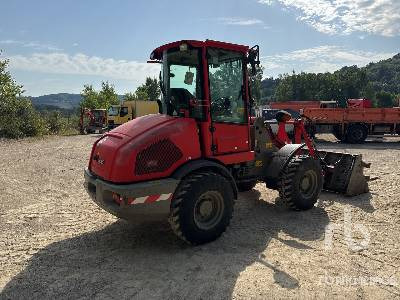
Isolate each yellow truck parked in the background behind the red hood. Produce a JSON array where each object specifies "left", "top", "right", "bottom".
[{"left": 107, "top": 100, "right": 159, "bottom": 129}]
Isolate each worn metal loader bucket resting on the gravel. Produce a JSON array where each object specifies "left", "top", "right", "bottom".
[{"left": 318, "top": 151, "right": 370, "bottom": 196}]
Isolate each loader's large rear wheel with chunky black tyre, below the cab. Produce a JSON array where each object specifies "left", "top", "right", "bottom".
[{"left": 169, "top": 172, "right": 234, "bottom": 245}]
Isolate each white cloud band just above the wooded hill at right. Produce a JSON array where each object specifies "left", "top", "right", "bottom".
[{"left": 261, "top": 46, "right": 395, "bottom": 77}]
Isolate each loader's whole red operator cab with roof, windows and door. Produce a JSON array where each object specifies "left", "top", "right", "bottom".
[{"left": 150, "top": 40, "right": 258, "bottom": 160}]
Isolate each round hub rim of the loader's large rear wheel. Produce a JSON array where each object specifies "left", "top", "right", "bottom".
[{"left": 194, "top": 191, "right": 224, "bottom": 230}]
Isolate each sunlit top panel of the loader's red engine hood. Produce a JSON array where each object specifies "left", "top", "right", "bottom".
[{"left": 110, "top": 114, "right": 175, "bottom": 138}]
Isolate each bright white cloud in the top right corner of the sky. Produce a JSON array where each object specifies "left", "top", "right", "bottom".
[{"left": 258, "top": 0, "right": 400, "bottom": 37}]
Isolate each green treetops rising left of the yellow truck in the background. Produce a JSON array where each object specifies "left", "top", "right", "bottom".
[{"left": 80, "top": 81, "right": 119, "bottom": 109}]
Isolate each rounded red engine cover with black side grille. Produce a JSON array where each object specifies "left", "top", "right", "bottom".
[{"left": 89, "top": 115, "right": 201, "bottom": 183}]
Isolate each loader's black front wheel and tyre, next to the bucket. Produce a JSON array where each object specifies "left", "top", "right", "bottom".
[{"left": 278, "top": 156, "right": 323, "bottom": 210}]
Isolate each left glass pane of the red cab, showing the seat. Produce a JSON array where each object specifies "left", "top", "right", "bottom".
[{"left": 162, "top": 48, "right": 202, "bottom": 116}]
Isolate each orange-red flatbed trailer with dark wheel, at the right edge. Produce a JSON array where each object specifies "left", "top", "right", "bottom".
[{"left": 302, "top": 107, "right": 400, "bottom": 144}]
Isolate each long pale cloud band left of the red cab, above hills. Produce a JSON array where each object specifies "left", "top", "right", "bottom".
[{"left": 7, "top": 53, "right": 160, "bottom": 82}]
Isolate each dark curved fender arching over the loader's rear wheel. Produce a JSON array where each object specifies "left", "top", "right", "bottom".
[{"left": 171, "top": 159, "right": 238, "bottom": 199}]
